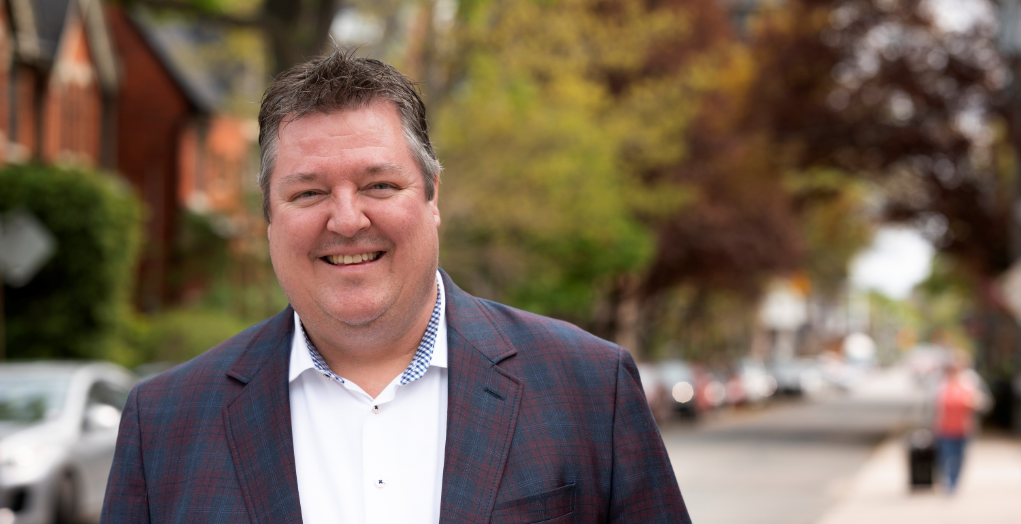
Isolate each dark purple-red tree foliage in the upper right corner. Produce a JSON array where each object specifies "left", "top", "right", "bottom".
[{"left": 753, "top": 0, "right": 1016, "bottom": 275}]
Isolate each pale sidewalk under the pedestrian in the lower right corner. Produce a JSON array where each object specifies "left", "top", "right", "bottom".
[{"left": 819, "top": 437, "right": 1021, "bottom": 524}]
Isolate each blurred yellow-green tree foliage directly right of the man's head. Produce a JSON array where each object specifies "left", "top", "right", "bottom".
[{"left": 435, "top": 0, "right": 697, "bottom": 321}]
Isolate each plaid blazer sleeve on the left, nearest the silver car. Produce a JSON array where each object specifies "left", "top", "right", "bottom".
[{"left": 99, "top": 386, "right": 149, "bottom": 524}]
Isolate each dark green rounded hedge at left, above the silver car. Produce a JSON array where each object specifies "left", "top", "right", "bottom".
[{"left": 0, "top": 164, "right": 142, "bottom": 360}]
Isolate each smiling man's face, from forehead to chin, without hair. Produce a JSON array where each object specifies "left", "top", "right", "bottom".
[{"left": 269, "top": 101, "right": 440, "bottom": 329}]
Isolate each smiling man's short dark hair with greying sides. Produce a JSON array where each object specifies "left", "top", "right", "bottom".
[{"left": 258, "top": 49, "right": 442, "bottom": 222}]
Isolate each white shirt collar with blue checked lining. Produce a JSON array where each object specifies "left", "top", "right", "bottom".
[{"left": 288, "top": 271, "right": 447, "bottom": 385}]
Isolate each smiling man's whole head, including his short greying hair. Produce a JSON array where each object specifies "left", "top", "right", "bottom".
[{"left": 259, "top": 53, "right": 440, "bottom": 342}]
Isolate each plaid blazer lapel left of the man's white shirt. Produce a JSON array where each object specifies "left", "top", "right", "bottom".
[{"left": 224, "top": 306, "right": 301, "bottom": 524}]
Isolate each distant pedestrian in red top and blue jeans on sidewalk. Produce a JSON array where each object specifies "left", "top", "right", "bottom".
[{"left": 933, "top": 352, "right": 988, "bottom": 493}]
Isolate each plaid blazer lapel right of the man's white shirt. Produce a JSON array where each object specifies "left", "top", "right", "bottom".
[{"left": 440, "top": 273, "right": 522, "bottom": 523}]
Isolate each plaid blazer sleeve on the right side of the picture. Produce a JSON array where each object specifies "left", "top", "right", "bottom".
[{"left": 610, "top": 349, "right": 691, "bottom": 524}]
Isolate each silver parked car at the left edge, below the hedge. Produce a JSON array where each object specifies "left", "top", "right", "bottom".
[{"left": 0, "top": 362, "right": 136, "bottom": 524}]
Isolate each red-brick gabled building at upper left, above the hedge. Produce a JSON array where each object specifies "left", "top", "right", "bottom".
[{"left": 7, "top": 0, "right": 254, "bottom": 309}]
